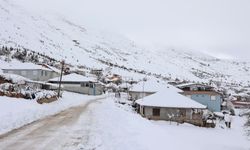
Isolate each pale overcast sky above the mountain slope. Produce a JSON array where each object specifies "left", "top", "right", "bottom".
[{"left": 14, "top": 0, "right": 250, "bottom": 60}]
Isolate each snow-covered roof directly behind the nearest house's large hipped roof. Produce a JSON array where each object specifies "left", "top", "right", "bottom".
[{"left": 130, "top": 80, "right": 183, "bottom": 92}]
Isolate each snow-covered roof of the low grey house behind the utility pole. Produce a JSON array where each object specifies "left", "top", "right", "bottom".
[{"left": 49, "top": 73, "right": 96, "bottom": 82}]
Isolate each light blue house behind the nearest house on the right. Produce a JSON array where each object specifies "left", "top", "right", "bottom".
[{"left": 177, "top": 83, "right": 222, "bottom": 112}]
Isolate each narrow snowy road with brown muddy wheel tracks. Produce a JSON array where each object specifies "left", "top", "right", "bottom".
[{"left": 0, "top": 98, "right": 104, "bottom": 150}]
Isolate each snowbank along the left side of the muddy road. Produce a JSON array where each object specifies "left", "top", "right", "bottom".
[{"left": 0, "top": 92, "right": 102, "bottom": 134}]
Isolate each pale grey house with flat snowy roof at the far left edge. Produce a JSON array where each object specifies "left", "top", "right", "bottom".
[{"left": 0, "top": 63, "right": 59, "bottom": 81}]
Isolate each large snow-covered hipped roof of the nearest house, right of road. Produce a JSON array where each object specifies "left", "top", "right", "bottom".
[{"left": 136, "top": 89, "right": 206, "bottom": 109}]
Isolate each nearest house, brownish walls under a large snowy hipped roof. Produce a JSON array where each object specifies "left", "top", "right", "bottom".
[{"left": 136, "top": 89, "right": 207, "bottom": 126}]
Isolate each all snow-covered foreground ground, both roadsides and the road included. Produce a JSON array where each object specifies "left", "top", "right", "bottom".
[{"left": 0, "top": 93, "right": 250, "bottom": 150}]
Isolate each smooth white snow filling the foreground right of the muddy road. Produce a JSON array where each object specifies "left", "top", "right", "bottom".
[{"left": 84, "top": 98, "right": 250, "bottom": 150}]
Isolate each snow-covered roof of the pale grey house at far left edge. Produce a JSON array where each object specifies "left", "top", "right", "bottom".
[{"left": 0, "top": 63, "right": 51, "bottom": 71}]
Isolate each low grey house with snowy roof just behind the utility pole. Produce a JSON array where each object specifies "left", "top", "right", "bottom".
[{"left": 49, "top": 73, "right": 103, "bottom": 95}]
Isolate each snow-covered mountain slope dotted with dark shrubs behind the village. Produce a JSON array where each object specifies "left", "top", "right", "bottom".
[{"left": 0, "top": 0, "right": 250, "bottom": 85}]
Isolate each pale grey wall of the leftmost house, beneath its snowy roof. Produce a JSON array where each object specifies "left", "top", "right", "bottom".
[{"left": 3, "top": 69, "right": 59, "bottom": 81}]
